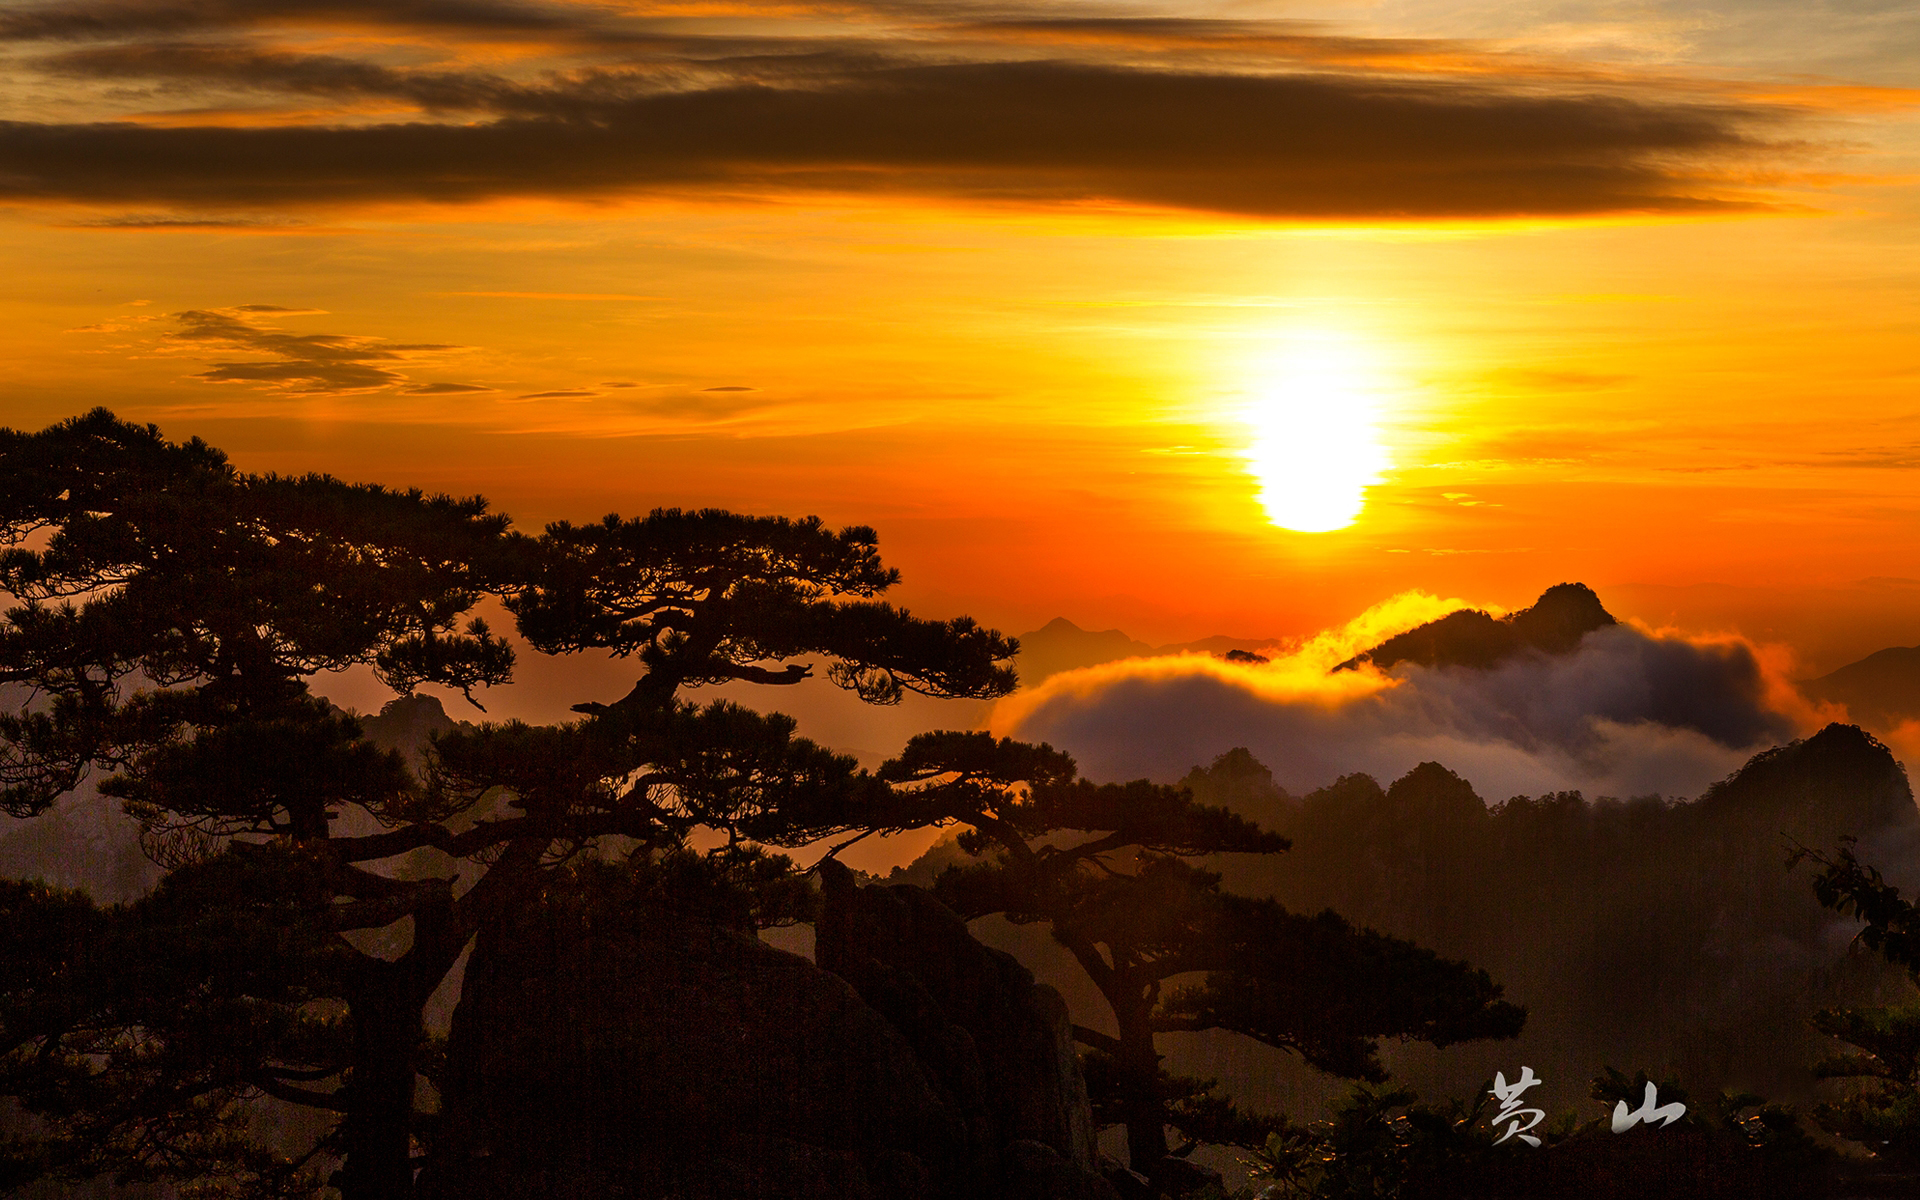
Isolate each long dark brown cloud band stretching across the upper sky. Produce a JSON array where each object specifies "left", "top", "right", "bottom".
[{"left": 0, "top": 61, "right": 1778, "bottom": 217}]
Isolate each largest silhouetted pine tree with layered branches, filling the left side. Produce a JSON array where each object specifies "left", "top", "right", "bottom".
[{"left": 0, "top": 411, "right": 1016, "bottom": 1200}]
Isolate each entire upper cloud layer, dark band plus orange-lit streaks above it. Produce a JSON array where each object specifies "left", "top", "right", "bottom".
[{"left": 0, "top": 0, "right": 1820, "bottom": 219}]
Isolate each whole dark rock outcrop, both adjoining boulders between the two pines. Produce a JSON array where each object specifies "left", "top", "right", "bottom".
[{"left": 420, "top": 862, "right": 1114, "bottom": 1200}]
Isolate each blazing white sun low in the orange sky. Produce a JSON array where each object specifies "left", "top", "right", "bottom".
[{"left": 1242, "top": 334, "right": 1390, "bottom": 534}]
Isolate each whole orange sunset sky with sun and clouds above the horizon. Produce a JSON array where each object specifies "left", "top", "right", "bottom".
[{"left": 0, "top": 0, "right": 1920, "bottom": 702}]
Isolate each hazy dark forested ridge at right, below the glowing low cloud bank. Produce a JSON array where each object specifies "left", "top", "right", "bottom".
[{"left": 1221, "top": 726, "right": 1920, "bottom": 1102}]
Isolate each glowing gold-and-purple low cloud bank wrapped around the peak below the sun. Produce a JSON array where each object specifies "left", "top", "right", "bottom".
[{"left": 995, "top": 595, "right": 1818, "bottom": 799}]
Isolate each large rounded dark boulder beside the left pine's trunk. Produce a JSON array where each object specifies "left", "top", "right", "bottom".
[{"left": 420, "top": 893, "right": 972, "bottom": 1200}]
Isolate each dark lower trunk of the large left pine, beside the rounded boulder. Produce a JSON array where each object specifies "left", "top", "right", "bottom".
[{"left": 332, "top": 972, "right": 422, "bottom": 1200}]
